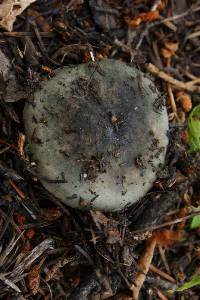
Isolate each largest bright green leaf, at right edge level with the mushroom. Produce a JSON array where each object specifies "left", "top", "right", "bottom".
[{"left": 188, "top": 104, "right": 200, "bottom": 151}]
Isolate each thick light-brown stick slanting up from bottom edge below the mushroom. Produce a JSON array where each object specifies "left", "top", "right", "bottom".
[{"left": 131, "top": 237, "right": 156, "bottom": 300}]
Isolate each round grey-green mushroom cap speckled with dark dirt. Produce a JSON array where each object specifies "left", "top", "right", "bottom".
[{"left": 24, "top": 59, "right": 168, "bottom": 211}]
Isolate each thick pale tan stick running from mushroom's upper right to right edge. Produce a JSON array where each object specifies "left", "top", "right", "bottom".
[{"left": 147, "top": 63, "right": 200, "bottom": 93}]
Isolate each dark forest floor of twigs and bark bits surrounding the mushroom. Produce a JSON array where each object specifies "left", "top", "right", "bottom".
[{"left": 0, "top": 0, "right": 200, "bottom": 300}]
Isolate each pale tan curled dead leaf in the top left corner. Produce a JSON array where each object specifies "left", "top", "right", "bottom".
[{"left": 0, "top": 0, "right": 36, "bottom": 31}]
